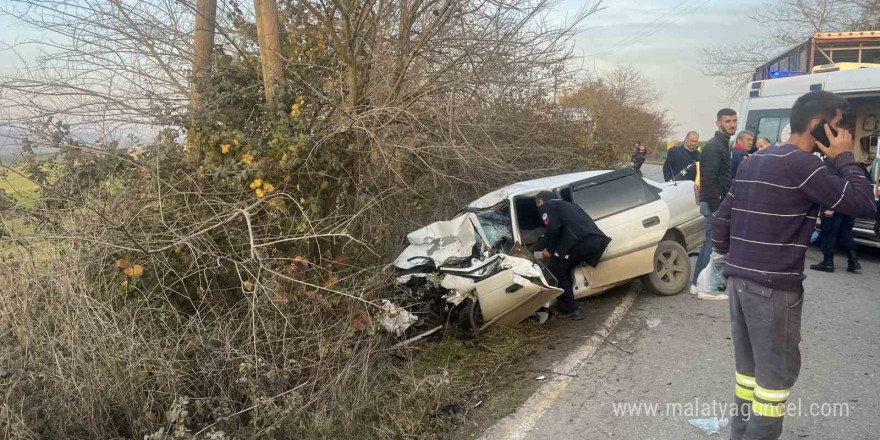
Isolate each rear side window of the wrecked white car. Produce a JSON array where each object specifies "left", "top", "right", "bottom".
[{"left": 572, "top": 176, "right": 659, "bottom": 220}]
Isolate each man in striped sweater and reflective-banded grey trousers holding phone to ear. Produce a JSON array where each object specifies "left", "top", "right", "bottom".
[{"left": 712, "top": 91, "right": 874, "bottom": 440}]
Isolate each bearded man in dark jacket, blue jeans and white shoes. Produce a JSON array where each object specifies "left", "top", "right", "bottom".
[{"left": 691, "top": 108, "right": 737, "bottom": 299}]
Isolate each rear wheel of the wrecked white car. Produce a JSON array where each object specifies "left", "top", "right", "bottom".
[{"left": 642, "top": 240, "right": 691, "bottom": 296}]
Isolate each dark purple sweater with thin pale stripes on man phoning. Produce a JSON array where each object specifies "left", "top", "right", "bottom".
[{"left": 712, "top": 145, "right": 874, "bottom": 291}]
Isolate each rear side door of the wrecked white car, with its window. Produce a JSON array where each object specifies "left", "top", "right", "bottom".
[{"left": 563, "top": 170, "right": 670, "bottom": 296}]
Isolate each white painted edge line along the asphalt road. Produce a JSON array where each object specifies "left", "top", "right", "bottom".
[{"left": 480, "top": 289, "right": 638, "bottom": 440}]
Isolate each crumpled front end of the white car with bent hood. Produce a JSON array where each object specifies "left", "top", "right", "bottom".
[{"left": 394, "top": 209, "right": 562, "bottom": 330}]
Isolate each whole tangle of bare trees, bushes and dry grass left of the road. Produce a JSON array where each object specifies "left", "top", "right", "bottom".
[{"left": 0, "top": 0, "right": 668, "bottom": 440}]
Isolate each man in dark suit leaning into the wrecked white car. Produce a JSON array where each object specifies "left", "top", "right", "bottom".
[{"left": 535, "top": 191, "right": 611, "bottom": 320}]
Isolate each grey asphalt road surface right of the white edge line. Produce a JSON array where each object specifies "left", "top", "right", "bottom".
[{"left": 483, "top": 166, "right": 880, "bottom": 440}]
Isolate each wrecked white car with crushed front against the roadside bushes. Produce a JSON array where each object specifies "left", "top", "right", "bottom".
[{"left": 394, "top": 170, "right": 705, "bottom": 330}]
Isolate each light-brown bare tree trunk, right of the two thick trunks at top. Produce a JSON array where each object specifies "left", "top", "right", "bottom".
[{"left": 254, "top": 0, "right": 282, "bottom": 102}]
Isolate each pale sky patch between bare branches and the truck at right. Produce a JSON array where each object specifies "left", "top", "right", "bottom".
[{"left": 563, "top": 0, "right": 764, "bottom": 139}]
